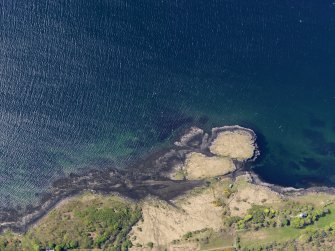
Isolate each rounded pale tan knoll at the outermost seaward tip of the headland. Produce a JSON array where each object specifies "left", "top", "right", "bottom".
[{"left": 210, "top": 130, "right": 255, "bottom": 161}]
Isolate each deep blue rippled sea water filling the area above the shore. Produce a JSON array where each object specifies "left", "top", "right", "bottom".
[{"left": 0, "top": 0, "right": 335, "bottom": 206}]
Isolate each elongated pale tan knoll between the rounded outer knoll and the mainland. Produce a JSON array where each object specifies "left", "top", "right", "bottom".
[{"left": 185, "top": 153, "right": 236, "bottom": 180}]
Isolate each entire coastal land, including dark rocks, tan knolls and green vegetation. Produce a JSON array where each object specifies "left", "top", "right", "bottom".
[{"left": 0, "top": 126, "right": 335, "bottom": 251}]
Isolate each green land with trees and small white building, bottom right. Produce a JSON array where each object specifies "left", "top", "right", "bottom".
[{"left": 236, "top": 202, "right": 335, "bottom": 250}]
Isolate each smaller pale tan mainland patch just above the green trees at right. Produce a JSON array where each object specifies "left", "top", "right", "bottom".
[{"left": 229, "top": 184, "right": 282, "bottom": 217}]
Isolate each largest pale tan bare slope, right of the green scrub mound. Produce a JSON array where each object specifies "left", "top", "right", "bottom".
[{"left": 130, "top": 189, "right": 223, "bottom": 250}]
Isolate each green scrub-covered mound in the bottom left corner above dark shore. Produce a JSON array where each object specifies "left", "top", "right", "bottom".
[{"left": 0, "top": 194, "right": 141, "bottom": 251}]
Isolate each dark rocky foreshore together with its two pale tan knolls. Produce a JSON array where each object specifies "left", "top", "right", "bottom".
[{"left": 0, "top": 126, "right": 259, "bottom": 232}]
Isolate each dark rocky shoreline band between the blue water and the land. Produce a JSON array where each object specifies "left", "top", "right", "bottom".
[{"left": 0, "top": 126, "right": 335, "bottom": 233}]
